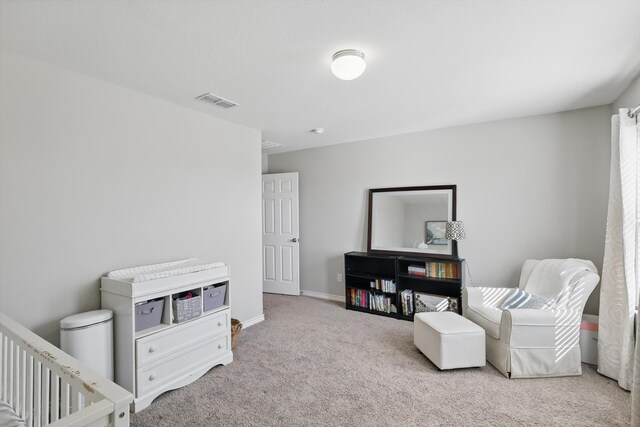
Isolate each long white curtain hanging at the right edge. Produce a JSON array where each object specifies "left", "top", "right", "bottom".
[{"left": 598, "top": 108, "right": 640, "bottom": 398}]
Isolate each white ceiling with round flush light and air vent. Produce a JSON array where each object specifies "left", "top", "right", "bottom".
[{"left": 0, "top": 0, "right": 640, "bottom": 152}]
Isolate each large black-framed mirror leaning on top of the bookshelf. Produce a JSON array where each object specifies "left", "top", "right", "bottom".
[{"left": 367, "top": 185, "right": 457, "bottom": 257}]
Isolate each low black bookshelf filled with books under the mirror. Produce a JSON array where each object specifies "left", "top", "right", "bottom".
[{"left": 344, "top": 252, "right": 463, "bottom": 321}]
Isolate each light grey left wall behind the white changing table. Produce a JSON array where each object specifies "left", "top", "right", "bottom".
[{"left": 0, "top": 52, "right": 262, "bottom": 343}]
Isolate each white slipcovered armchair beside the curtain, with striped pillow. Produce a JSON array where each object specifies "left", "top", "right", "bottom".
[{"left": 462, "top": 259, "right": 600, "bottom": 378}]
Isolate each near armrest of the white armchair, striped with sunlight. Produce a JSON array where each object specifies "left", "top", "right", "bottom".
[{"left": 500, "top": 309, "right": 582, "bottom": 348}]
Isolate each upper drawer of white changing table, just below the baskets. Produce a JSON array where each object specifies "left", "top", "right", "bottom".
[{"left": 136, "top": 310, "right": 230, "bottom": 367}]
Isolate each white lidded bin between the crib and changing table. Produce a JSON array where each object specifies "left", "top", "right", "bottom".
[{"left": 60, "top": 310, "right": 113, "bottom": 381}]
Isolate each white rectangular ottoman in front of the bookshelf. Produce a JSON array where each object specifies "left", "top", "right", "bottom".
[{"left": 413, "top": 311, "right": 486, "bottom": 369}]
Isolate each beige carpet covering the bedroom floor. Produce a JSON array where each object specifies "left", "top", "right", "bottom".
[{"left": 131, "top": 294, "right": 631, "bottom": 427}]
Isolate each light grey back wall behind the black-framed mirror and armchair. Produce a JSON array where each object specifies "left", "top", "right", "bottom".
[{"left": 269, "top": 106, "right": 610, "bottom": 313}]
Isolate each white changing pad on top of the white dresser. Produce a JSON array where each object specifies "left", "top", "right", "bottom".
[{"left": 107, "top": 258, "right": 225, "bottom": 283}]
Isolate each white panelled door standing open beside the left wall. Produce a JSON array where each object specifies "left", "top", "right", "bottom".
[{"left": 262, "top": 172, "right": 300, "bottom": 295}]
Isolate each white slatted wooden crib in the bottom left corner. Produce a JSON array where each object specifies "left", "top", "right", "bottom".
[{"left": 0, "top": 313, "right": 133, "bottom": 427}]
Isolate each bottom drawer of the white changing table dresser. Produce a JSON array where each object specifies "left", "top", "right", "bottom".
[{"left": 136, "top": 334, "right": 231, "bottom": 397}]
